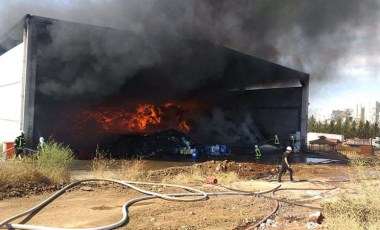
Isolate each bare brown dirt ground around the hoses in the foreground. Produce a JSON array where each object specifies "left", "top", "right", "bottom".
[{"left": 0, "top": 158, "right": 378, "bottom": 230}]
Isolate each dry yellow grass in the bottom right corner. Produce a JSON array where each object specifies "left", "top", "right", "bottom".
[{"left": 324, "top": 154, "right": 380, "bottom": 230}]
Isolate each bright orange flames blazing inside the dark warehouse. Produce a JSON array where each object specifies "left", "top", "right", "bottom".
[{"left": 79, "top": 102, "right": 194, "bottom": 133}]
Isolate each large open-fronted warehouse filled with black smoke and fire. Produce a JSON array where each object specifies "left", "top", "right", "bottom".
[{"left": 0, "top": 15, "right": 309, "bottom": 158}]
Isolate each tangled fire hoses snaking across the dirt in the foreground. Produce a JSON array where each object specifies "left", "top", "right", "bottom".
[{"left": 0, "top": 179, "right": 335, "bottom": 230}]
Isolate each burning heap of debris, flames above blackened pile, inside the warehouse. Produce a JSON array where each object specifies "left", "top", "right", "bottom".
[{"left": 72, "top": 98, "right": 259, "bottom": 158}]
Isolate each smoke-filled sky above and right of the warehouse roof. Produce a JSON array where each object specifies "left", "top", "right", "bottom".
[{"left": 0, "top": 0, "right": 380, "bottom": 117}]
